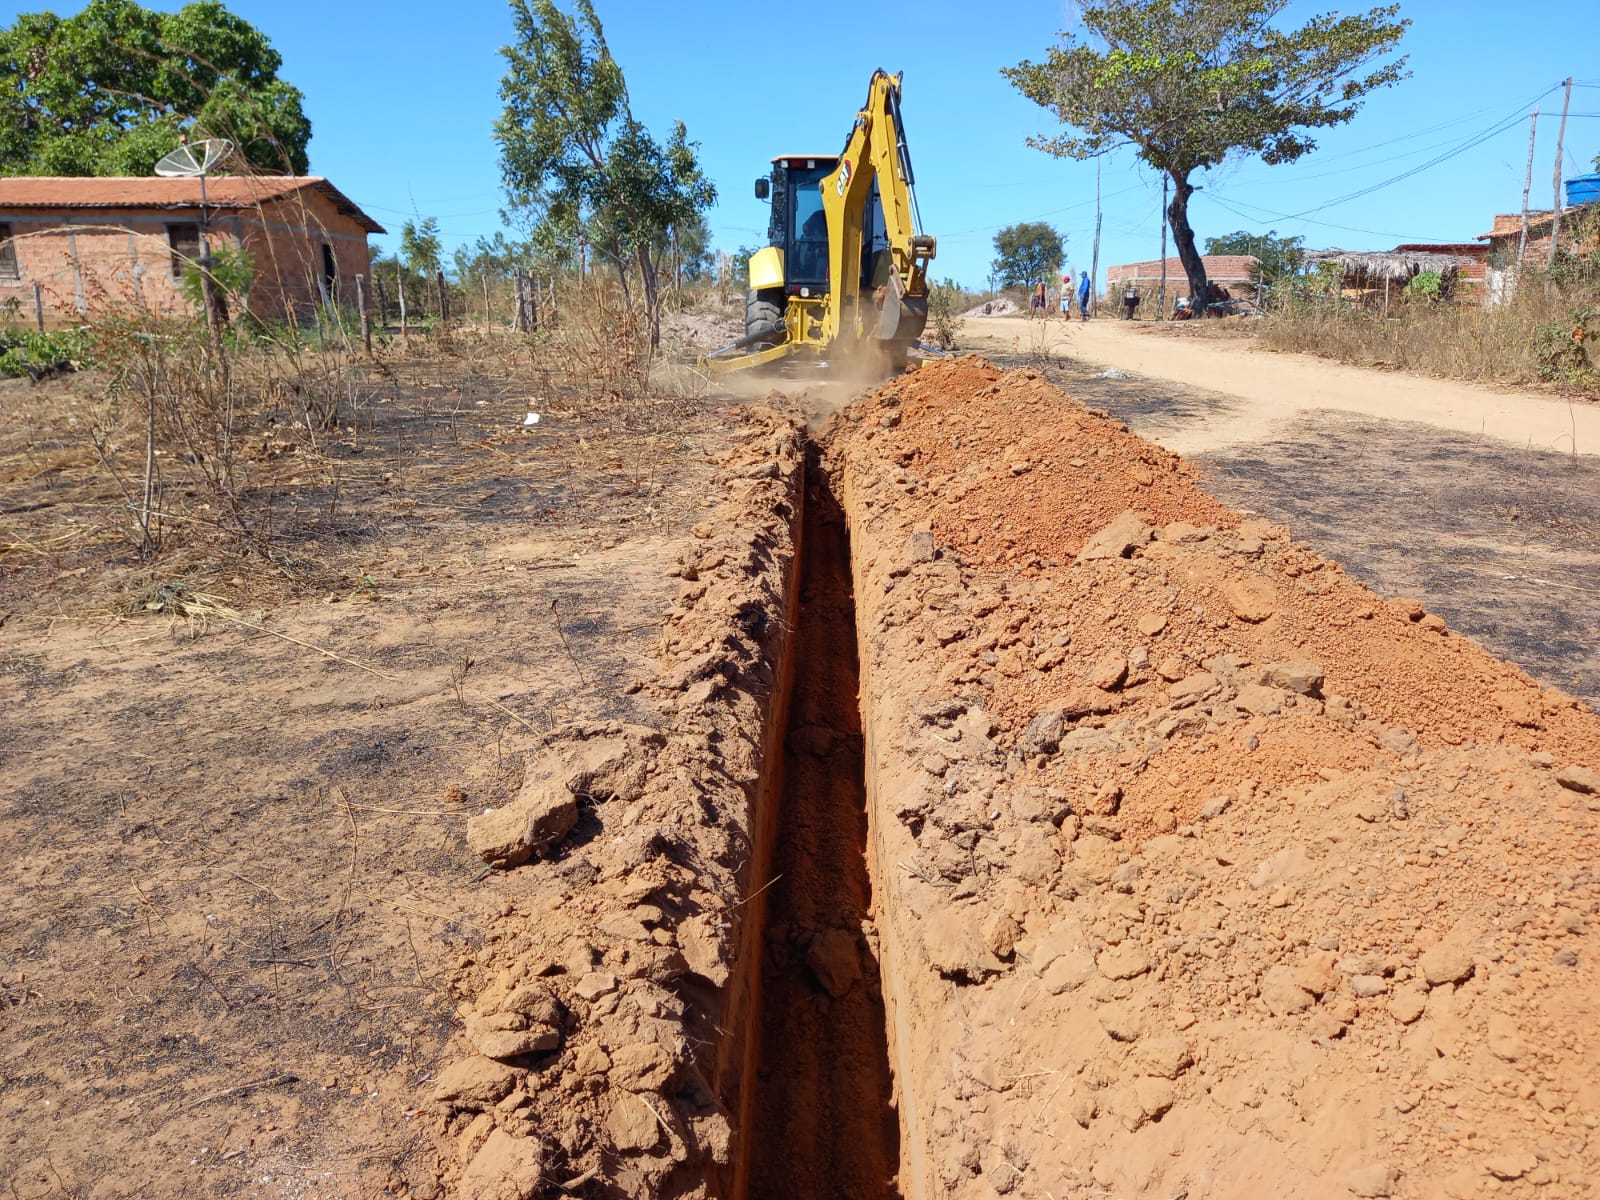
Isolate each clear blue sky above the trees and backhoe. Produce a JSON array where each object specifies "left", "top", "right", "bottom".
[{"left": 9, "top": 0, "right": 1600, "bottom": 286}]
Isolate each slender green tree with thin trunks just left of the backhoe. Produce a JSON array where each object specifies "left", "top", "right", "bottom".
[{"left": 494, "top": 0, "right": 717, "bottom": 346}]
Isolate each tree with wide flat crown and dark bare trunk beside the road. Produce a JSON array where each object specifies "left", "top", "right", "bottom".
[{"left": 1002, "top": 0, "right": 1411, "bottom": 315}]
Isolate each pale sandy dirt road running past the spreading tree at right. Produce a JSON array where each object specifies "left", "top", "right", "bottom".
[{"left": 962, "top": 317, "right": 1600, "bottom": 456}]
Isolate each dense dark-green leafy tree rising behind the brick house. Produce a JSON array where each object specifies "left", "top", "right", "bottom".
[{"left": 0, "top": 0, "right": 310, "bottom": 174}]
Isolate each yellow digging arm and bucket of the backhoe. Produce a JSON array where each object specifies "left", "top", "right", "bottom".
[{"left": 821, "top": 70, "right": 936, "bottom": 352}]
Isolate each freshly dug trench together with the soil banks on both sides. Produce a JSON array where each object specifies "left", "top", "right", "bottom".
[{"left": 434, "top": 358, "right": 1600, "bottom": 1200}]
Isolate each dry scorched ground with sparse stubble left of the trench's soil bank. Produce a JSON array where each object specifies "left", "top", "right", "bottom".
[{"left": 0, "top": 360, "right": 741, "bottom": 1197}]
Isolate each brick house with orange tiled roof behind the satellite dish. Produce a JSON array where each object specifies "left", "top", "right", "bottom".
[{"left": 0, "top": 176, "right": 386, "bottom": 322}]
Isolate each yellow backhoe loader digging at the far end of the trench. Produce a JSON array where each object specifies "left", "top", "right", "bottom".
[{"left": 704, "top": 70, "right": 934, "bottom": 371}]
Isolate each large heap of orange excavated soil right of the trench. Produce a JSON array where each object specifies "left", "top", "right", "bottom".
[{"left": 824, "top": 358, "right": 1600, "bottom": 1200}]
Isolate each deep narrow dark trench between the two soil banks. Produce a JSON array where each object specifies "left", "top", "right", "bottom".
[{"left": 746, "top": 446, "right": 899, "bottom": 1200}]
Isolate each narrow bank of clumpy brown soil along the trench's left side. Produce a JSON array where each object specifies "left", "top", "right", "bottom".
[{"left": 419, "top": 408, "right": 803, "bottom": 1200}]
